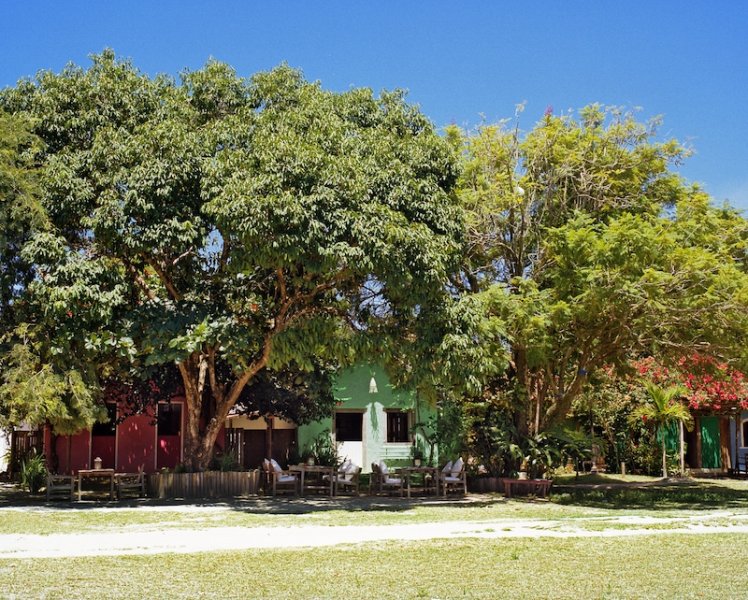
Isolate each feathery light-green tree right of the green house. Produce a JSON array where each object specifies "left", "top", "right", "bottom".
[{"left": 450, "top": 106, "right": 748, "bottom": 436}]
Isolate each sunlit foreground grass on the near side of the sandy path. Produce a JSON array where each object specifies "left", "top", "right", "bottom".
[{"left": 0, "top": 534, "right": 748, "bottom": 600}]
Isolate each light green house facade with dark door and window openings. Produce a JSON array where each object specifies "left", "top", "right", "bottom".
[{"left": 298, "top": 365, "right": 436, "bottom": 473}]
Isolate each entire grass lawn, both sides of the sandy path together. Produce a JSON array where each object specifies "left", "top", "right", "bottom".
[{"left": 0, "top": 476, "right": 748, "bottom": 600}]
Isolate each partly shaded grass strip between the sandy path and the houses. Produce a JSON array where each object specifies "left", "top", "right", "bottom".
[{"left": 0, "top": 475, "right": 748, "bottom": 534}]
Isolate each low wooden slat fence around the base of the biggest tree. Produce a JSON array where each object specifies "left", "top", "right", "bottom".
[{"left": 148, "top": 469, "right": 260, "bottom": 498}]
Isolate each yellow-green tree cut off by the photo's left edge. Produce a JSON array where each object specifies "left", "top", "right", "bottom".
[{"left": 0, "top": 112, "right": 101, "bottom": 432}]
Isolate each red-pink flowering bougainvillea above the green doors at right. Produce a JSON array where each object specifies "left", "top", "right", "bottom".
[{"left": 634, "top": 353, "right": 748, "bottom": 411}]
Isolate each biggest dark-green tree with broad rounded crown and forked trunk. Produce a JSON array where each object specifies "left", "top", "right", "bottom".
[{"left": 0, "top": 52, "right": 461, "bottom": 468}]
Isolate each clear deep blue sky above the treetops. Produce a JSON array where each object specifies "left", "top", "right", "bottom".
[{"left": 0, "top": 0, "right": 748, "bottom": 209}]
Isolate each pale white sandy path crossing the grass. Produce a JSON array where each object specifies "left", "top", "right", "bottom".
[{"left": 0, "top": 514, "right": 748, "bottom": 559}]
